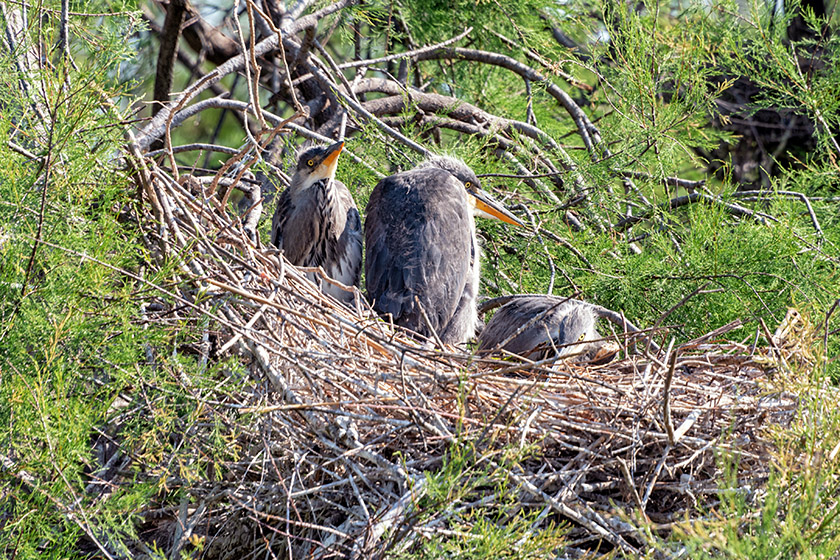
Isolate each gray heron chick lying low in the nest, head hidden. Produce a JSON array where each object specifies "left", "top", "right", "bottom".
[{"left": 478, "top": 296, "right": 619, "bottom": 363}]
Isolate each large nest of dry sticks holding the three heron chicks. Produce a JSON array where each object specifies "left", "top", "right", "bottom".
[{"left": 126, "top": 156, "right": 807, "bottom": 558}]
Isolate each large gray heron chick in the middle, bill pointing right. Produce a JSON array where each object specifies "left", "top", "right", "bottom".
[{"left": 365, "top": 156, "right": 523, "bottom": 344}]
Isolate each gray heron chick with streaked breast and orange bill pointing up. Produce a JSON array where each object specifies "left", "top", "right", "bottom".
[{"left": 271, "top": 142, "right": 362, "bottom": 302}]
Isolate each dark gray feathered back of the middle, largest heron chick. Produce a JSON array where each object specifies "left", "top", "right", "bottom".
[{"left": 365, "top": 168, "right": 472, "bottom": 335}]
